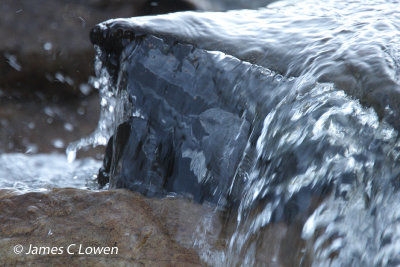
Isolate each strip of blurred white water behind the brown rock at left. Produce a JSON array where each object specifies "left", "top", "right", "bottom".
[{"left": 0, "top": 153, "right": 101, "bottom": 194}]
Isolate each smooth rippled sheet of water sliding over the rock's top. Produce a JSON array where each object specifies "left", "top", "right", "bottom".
[{"left": 92, "top": 5, "right": 400, "bottom": 128}]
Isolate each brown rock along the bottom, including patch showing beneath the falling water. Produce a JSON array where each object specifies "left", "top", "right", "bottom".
[{"left": 0, "top": 188, "right": 310, "bottom": 266}]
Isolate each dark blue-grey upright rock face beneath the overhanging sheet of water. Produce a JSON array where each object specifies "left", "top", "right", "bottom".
[{"left": 92, "top": 31, "right": 293, "bottom": 204}]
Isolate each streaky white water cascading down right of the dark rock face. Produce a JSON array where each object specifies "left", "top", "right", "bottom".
[{"left": 228, "top": 81, "right": 400, "bottom": 266}]
